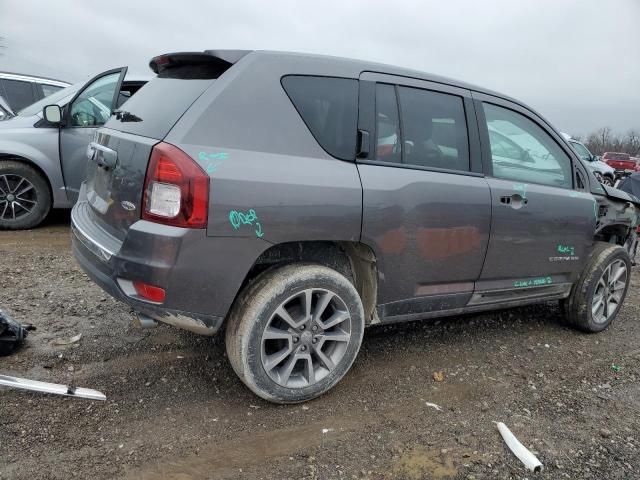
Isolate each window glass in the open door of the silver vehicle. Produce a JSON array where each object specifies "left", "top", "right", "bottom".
[{"left": 70, "top": 72, "right": 120, "bottom": 127}]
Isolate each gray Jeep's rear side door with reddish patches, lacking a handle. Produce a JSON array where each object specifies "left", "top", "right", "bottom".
[{"left": 357, "top": 73, "right": 491, "bottom": 321}]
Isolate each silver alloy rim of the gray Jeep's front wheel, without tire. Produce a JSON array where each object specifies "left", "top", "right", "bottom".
[{"left": 591, "top": 260, "right": 628, "bottom": 323}]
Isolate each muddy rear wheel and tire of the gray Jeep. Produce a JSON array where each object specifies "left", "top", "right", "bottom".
[{"left": 226, "top": 264, "right": 365, "bottom": 403}]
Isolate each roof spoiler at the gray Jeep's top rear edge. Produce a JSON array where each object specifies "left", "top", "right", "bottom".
[{"left": 149, "top": 50, "right": 251, "bottom": 79}]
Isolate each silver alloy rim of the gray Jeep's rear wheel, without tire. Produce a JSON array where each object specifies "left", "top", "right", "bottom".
[{"left": 261, "top": 288, "right": 351, "bottom": 388}]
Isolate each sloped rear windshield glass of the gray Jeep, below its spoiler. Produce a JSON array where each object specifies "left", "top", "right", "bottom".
[{"left": 105, "top": 77, "right": 214, "bottom": 140}]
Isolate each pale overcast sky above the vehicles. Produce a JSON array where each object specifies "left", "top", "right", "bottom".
[{"left": 0, "top": 0, "right": 640, "bottom": 134}]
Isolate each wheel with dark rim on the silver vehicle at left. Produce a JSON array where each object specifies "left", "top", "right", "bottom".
[{"left": 0, "top": 160, "right": 51, "bottom": 230}]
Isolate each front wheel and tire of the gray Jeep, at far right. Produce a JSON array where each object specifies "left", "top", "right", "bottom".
[{"left": 564, "top": 242, "right": 631, "bottom": 333}]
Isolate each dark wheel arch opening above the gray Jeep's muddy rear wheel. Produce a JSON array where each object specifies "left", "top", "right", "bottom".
[{"left": 234, "top": 241, "right": 379, "bottom": 324}]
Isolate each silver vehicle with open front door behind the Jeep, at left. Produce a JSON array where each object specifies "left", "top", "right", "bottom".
[{"left": 0, "top": 68, "right": 145, "bottom": 229}]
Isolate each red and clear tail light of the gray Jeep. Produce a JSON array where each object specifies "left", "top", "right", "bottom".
[{"left": 142, "top": 142, "right": 209, "bottom": 228}]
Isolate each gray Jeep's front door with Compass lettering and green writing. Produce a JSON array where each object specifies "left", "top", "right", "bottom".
[{"left": 471, "top": 93, "right": 596, "bottom": 303}]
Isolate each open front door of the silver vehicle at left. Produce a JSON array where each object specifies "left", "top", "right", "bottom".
[{"left": 60, "top": 67, "right": 127, "bottom": 205}]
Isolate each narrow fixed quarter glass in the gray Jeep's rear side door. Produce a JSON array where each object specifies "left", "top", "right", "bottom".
[{"left": 375, "top": 83, "right": 402, "bottom": 163}]
